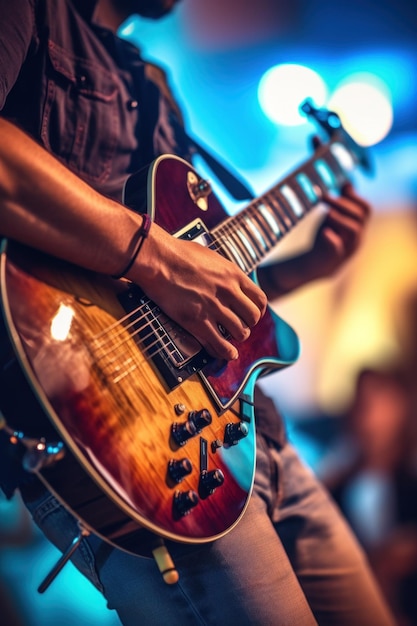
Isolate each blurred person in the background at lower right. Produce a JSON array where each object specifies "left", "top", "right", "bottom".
[{"left": 320, "top": 367, "right": 417, "bottom": 626}]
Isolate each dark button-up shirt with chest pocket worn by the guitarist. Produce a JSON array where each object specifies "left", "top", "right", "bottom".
[{"left": 0, "top": 0, "right": 190, "bottom": 200}]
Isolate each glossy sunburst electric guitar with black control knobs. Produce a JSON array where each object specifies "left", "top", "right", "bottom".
[{"left": 0, "top": 103, "right": 369, "bottom": 554}]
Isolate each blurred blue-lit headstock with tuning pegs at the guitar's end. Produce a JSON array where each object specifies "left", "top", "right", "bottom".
[{"left": 300, "top": 98, "right": 374, "bottom": 174}]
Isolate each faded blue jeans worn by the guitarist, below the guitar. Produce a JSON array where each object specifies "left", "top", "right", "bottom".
[{"left": 22, "top": 436, "right": 394, "bottom": 626}]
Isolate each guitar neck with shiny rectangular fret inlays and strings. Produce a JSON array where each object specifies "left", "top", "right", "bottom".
[{"left": 211, "top": 134, "right": 360, "bottom": 274}]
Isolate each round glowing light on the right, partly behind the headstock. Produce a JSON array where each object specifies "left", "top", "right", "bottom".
[{"left": 328, "top": 73, "right": 393, "bottom": 146}]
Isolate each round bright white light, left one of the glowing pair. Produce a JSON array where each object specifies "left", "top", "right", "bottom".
[{"left": 258, "top": 63, "right": 327, "bottom": 126}]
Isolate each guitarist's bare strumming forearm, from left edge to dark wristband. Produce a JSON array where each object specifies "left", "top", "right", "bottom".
[{"left": 0, "top": 118, "right": 142, "bottom": 274}]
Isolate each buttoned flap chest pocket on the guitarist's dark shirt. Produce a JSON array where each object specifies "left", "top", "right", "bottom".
[{"left": 41, "top": 40, "right": 119, "bottom": 183}]
